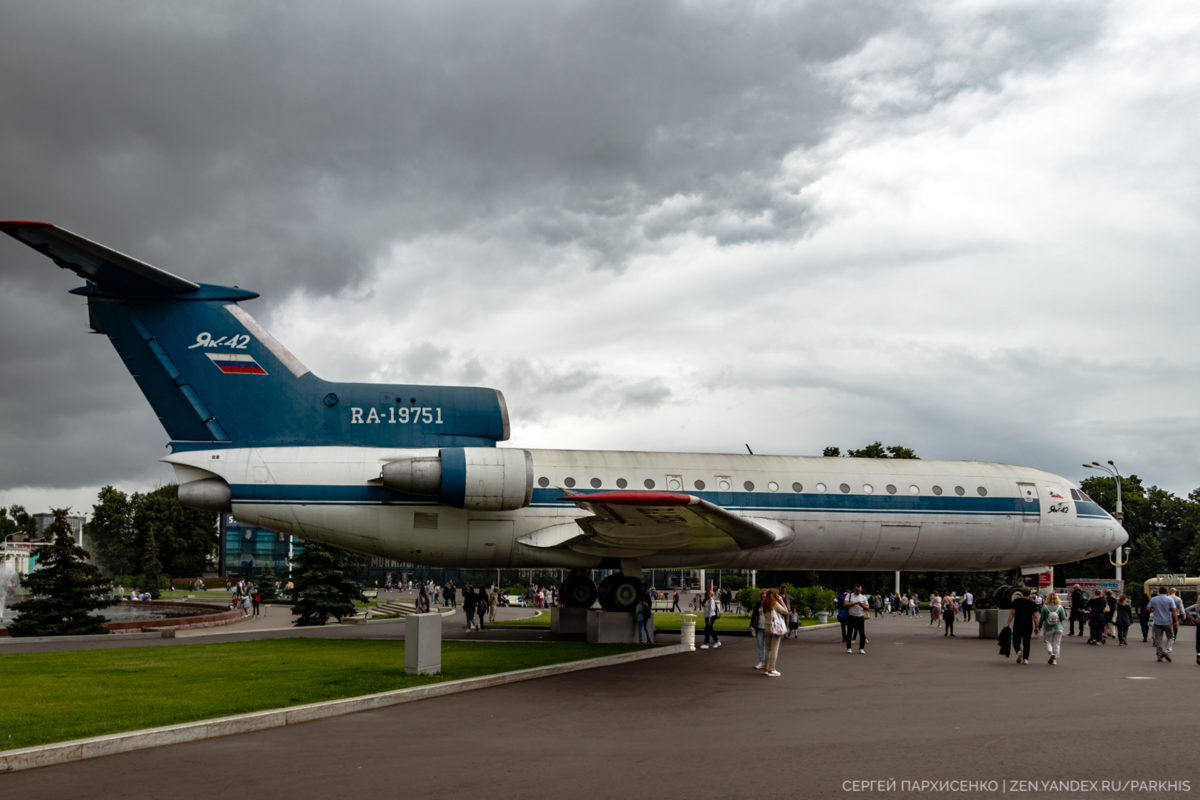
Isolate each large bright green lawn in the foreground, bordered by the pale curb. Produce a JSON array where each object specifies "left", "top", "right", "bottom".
[{"left": 0, "top": 639, "right": 638, "bottom": 750}]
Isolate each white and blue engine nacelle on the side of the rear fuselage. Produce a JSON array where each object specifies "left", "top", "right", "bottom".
[{"left": 382, "top": 447, "right": 533, "bottom": 511}]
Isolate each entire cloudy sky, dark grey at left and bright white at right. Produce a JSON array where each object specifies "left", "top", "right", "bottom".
[{"left": 0, "top": 0, "right": 1200, "bottom": 511}]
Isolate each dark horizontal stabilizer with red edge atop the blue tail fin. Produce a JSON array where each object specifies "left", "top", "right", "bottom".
[{"left": 0, "top": 219, "right": 200, "bottom": 295}]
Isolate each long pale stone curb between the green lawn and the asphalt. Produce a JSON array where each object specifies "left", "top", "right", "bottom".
[{"left": 0, "top": 644, "right": 691, "bottom": 772}]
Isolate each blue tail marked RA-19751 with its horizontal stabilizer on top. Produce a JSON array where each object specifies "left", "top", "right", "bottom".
[{"left": 0, "top": 222, "right": 509, "bottom": 447}]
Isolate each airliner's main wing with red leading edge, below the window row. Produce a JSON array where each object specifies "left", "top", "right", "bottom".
[{"left": 549, "top": 491, "right": 780, "bottom": 555}]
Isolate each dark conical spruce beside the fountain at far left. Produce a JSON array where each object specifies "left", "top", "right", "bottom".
[{"left": 8, "top": 509, "right": 116, "bottom": 636}]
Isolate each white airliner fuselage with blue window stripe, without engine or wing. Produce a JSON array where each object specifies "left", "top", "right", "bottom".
[{"left": 163, "top": 447, "right": 1127, "bottom": 571}]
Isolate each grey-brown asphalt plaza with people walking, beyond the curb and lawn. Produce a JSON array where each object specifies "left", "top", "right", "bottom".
[{"left": 0, "top": 612, "right": 1200, "bottom": 800}]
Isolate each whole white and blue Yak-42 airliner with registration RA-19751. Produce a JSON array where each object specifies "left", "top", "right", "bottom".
[{"left": 0, "top": 221, "right": 1127, "bottom": 610}]
